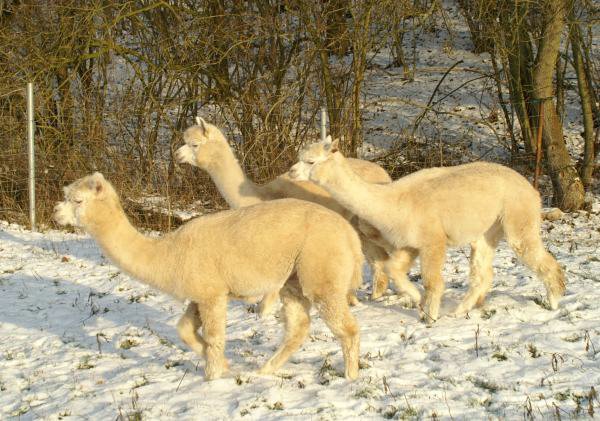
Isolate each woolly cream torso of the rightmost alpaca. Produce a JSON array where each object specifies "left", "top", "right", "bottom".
[{"left": 393, "top": 162, "right": 541, "bottom": 245}]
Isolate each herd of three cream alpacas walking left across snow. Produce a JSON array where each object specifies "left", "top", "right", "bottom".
[{"left": 54, "top": 118, "right": 565, "bottom": 380}]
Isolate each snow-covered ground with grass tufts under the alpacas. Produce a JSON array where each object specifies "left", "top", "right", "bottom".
[{"left": 0, "top": 200, "right": 600, "bottom": 420}]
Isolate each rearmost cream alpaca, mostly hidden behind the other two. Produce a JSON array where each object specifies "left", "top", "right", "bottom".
[{"left": 176, "top": 117, "right": 392, "bottom": 308}]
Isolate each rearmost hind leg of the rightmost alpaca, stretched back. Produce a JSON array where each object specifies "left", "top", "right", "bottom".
[{"left": 503, "top": 208, "right": 565, "bottom": 310}]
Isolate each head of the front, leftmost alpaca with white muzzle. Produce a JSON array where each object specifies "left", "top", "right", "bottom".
[{"left": 53, "top": 172, "right": 119, "bottom": 228}]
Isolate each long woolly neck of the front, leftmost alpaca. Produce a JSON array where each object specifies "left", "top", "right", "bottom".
[{"left": 87, "top": 203, "right": 177, "bottom": 294}]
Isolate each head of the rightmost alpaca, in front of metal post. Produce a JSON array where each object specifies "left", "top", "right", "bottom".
[{"left": 289, "top": 136, "right": 339, "bottom": 183}]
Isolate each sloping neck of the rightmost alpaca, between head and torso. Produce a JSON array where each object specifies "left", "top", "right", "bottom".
[{"left": 319, "top": 153, "right": 389, "bottom": 226}]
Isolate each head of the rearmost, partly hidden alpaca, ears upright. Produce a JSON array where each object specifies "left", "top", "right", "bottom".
[{"left": 175, "top": 117, "right": 229, "bottom": 170}]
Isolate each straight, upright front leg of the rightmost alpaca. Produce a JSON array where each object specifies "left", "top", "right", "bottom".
[{"left": 419, "top": 243, "right": 446, "bottom": 324}]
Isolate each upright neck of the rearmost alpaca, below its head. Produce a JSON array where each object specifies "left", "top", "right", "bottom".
[{"left": 206, "top": 141, "right": 262, "bottom": 209}]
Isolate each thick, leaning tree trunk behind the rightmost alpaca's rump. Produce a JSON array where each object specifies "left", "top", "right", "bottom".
[{"left": 533, "top": 0, "right": 584, "bottom": 211}]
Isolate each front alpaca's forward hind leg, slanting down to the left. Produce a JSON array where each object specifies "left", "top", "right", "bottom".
[{"left": 259, "top": 280, "right": 311, "bottom": 374}]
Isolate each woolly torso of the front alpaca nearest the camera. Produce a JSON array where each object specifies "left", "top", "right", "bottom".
[{"left": 173, "top": 199, "right": 362, "bottom": 297}]
